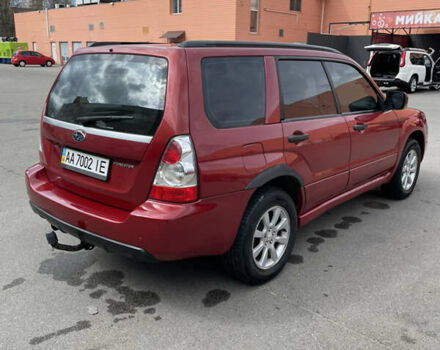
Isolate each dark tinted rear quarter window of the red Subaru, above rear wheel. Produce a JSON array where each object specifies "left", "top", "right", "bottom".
[{"left": 202, "top": 57, "right": 266, "bottom": 129}]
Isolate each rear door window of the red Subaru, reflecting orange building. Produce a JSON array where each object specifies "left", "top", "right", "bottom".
[{"left": 278, "top": 60, "right": 337, "bottom": 119}]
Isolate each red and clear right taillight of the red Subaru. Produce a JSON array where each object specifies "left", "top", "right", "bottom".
[{"left": 150, "top": 135, "right": 198, "bottom": 203}]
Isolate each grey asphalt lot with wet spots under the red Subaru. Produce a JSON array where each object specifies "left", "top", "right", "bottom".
[{"left": 0, "top": 65, "right": 440, "bottom": 350}]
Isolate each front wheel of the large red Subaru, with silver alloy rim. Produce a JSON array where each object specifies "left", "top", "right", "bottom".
[{"left": 382, "top": 139, "right": 422, "bottom": 199}]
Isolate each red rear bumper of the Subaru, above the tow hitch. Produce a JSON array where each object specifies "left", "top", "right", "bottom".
[{"left": 26, "top": 164, "right": 253, "bottom": 261}]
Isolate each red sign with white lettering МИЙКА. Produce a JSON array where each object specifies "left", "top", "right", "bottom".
[{"left": 370, "top": 9, "right": 440, "bottom": 29}]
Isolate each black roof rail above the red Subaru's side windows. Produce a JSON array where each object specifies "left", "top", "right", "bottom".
[{"left": 178, "top": 40, "right": 341, "bottom": 53}]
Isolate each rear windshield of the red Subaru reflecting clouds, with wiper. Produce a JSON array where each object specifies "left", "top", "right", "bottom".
[{"left": 46, "top": 54, "right": 168, "bottom": 136}]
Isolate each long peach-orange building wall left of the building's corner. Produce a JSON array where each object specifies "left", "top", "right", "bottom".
[{"left": 15, "top": 0, "right": 236, "bottom": 63}]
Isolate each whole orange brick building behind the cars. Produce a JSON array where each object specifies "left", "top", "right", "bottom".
[{"left": 15, "top": 0, "right": 440, "bottom": 63}]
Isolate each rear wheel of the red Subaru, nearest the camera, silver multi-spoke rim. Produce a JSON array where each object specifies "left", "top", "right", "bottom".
[{"left": 224, "top": 187, "right": 297, "bottom": 285}]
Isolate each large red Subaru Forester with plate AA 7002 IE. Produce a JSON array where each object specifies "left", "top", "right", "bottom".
[{"left": 26, "top": 41, "right": 427, "bottom": 284}]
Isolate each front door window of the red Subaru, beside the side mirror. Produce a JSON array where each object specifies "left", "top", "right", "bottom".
[{"left": 325, "top": 62, "right": 380, "bottom": 113}]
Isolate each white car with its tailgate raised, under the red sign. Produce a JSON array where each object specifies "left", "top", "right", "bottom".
[{"left": 365, "top": 44, "right": 440, "bottom": 92}]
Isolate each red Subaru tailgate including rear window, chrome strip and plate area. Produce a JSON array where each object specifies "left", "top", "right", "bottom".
[{"left": 41, "top": 47, "right": 187, "bottom": 210}]
